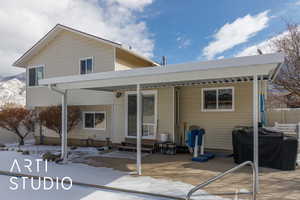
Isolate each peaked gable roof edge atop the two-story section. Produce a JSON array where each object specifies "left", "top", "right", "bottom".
[{"left": 13, "top": 24, "right": 159, "bottom": 67}]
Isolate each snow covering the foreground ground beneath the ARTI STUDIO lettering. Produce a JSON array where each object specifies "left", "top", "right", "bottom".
[{"left": 0, "top": 150, "right": 230, "bottom": 200}]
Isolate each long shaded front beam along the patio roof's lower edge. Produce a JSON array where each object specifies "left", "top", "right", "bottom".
[{"left": 44, "top": 69, "right": 276, "bottom": 91}]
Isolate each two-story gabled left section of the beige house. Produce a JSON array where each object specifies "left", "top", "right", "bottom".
[{"left": 14, "top": 24, "right": 158, "bottom": 145}]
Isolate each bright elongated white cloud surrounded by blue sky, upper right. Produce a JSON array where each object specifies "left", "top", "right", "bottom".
[{"left": 202, "top": 11, "right": 270, "bottom": 59}]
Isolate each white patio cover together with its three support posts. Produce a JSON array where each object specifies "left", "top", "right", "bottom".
[{"left": 40, "top": 53, "right": 284, "bottom": 190}]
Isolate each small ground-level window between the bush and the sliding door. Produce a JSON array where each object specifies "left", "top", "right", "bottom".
[{"left": 83, "top": 112, "right": 106, "bottom": 130}]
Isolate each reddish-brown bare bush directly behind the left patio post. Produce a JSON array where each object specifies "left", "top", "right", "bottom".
[{"left": 39, "top": 106, "right": 80, "bottom": 138}]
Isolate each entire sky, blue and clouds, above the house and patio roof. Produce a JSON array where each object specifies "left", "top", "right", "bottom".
[{"left": 0, "top": 0, "right": 300, "bottom": 76}]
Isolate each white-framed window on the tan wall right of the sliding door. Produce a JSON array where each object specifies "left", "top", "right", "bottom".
[{"left": 202, "top": 87, "right": 234, "bottom": 111}]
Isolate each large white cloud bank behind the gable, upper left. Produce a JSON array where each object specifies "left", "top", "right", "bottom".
[{"left": 0, "top": 0, "right": 154, "bottom": 75}]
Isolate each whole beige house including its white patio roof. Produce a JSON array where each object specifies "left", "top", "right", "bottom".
[{"left": 14, "top": 25, "right": 284, "bottom": 153}]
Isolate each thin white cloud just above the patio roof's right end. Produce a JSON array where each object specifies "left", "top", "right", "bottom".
[{"left": 235, "top": 31, "right": 288, "bottom": 57}]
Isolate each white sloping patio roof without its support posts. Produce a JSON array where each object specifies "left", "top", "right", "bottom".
[{"left": 40, "top": 53, "right": 284, "bottom": 90}]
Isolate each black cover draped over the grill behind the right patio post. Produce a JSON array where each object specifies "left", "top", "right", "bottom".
[{"left": 232, "top": 127, "right": 298, "bottom": 170}]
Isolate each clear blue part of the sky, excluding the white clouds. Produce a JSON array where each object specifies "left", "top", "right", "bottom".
[{"left": 139, "top": 0, "right": 300, "bottom": 63}]
